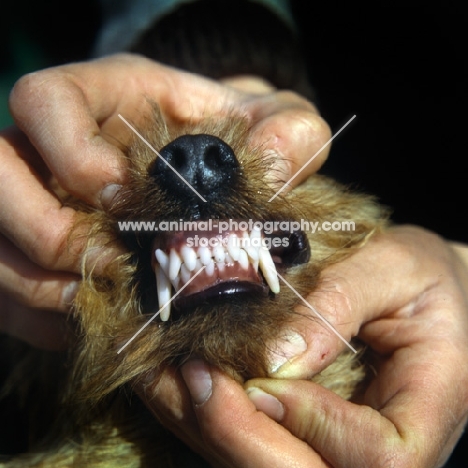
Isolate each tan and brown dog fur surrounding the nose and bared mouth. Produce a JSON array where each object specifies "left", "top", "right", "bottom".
[{"left": 1, "top": 105, "right": 385, "bottom": 467}]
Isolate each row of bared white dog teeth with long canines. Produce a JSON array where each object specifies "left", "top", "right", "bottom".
[{"left": 155, "top": 229, "right": 280, "bottom": 321}]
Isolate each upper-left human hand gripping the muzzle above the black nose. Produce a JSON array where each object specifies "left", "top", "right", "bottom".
[{"left": 0, "top": 54, "right": 330, "bottom": 348}]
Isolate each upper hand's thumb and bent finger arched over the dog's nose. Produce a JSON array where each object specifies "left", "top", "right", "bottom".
[{"left": 10, "top": 54, "right": 330, "bottom": 206}]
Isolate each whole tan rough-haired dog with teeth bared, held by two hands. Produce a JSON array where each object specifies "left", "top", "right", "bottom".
[{"left": 0, "top": 103, "right": 387, "bottom": 468}]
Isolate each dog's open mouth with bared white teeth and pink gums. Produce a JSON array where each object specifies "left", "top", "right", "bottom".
[{"left": 152, "top": 223, "right": 310, "bottom": 321}]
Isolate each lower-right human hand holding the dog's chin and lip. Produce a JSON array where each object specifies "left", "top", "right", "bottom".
[{"left": 141, "top": 227, "right": 468, "bottom": 468}]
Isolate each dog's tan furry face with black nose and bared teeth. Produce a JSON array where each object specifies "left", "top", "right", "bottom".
[{"left": 70, "top": 108, "right": 380, "bottom": 398}]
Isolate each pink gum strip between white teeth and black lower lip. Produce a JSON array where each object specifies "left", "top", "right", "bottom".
[{"left": 181, "top": 262, "right": 263, "bottom": 296}]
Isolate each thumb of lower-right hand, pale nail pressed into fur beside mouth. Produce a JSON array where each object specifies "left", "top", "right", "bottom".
[{"left": 269, "top": 226, "right": 446, "bottom": 379}]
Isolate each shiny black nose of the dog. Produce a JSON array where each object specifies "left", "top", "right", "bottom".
[{"left": 149, "top": 134, "right": 239, "bottom": 195}]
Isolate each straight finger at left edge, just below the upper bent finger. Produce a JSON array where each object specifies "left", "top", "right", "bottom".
[{"left": 0, "top": 128, "right": 79, "bottom": 272}]
